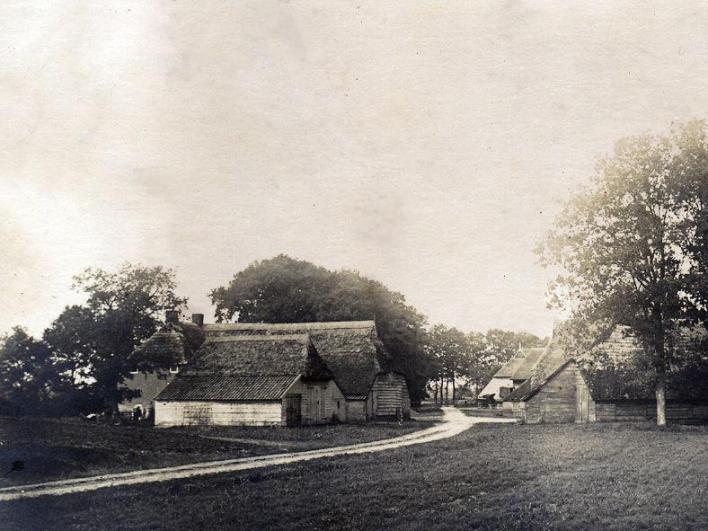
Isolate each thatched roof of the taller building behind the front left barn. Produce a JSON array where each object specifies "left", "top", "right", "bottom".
[{"left": 204, "top": 321, "right": 386, "bottom": 400}]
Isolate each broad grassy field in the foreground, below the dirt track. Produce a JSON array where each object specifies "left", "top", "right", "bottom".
[{"left": 5, "top": 424, "right": 708, "bottom": 529}]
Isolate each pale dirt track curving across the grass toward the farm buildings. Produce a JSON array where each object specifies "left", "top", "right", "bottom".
[{"left": 0, "top": 408, "right": 513, "bottom": 501}]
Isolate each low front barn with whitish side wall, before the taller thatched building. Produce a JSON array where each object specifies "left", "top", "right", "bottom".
[{"left": 155, "top": 334, "right": 345, "bottom": 427}]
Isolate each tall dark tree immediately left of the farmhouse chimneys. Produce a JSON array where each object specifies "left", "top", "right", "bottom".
[{"left": 44, "top": 264, "right": 187, "bottom": 414}]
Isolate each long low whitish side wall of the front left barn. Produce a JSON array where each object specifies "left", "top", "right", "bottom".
[{"left": 155, "top": 400, "right": 281, "bottom": 427}]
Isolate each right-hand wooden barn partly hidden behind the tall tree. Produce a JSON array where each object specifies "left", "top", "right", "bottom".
[{"left": 505, "top": 326, "right": 708, "bottom": 424}]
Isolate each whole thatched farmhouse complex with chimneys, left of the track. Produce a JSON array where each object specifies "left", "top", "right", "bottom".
[{"left": 121, "top": 314, "right": 410, "bottom": 426}]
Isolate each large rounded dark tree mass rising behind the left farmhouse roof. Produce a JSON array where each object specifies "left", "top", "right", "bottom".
[{"left": 210, "top": 255, "right": 430, "bottom": 403}]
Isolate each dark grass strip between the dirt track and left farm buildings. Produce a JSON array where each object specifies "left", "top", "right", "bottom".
[{"left": 0, "top": 417, "right": 431, "bottom": 487}]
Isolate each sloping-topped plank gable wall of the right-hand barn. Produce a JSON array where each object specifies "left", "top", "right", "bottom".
[{"left": 525, "top": 364, "right": 577, "bottom": 424}]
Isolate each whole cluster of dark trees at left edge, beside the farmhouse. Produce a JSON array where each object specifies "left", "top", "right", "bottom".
[{"left": 0, "top": 264, "right": 186, "bottom": 414}]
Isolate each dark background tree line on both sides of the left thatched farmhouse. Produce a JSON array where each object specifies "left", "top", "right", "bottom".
[{"left": 0, "top": 255, "right": 538, "bottom": 415}]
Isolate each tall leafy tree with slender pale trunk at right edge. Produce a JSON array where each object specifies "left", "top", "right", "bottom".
[{"left": 539, "top": 122, "right": 708, "bottom": 425}]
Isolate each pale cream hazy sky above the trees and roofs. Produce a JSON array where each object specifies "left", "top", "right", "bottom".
[{"left": 0, "top": 0, "right": 708, "bottom": 335}]
